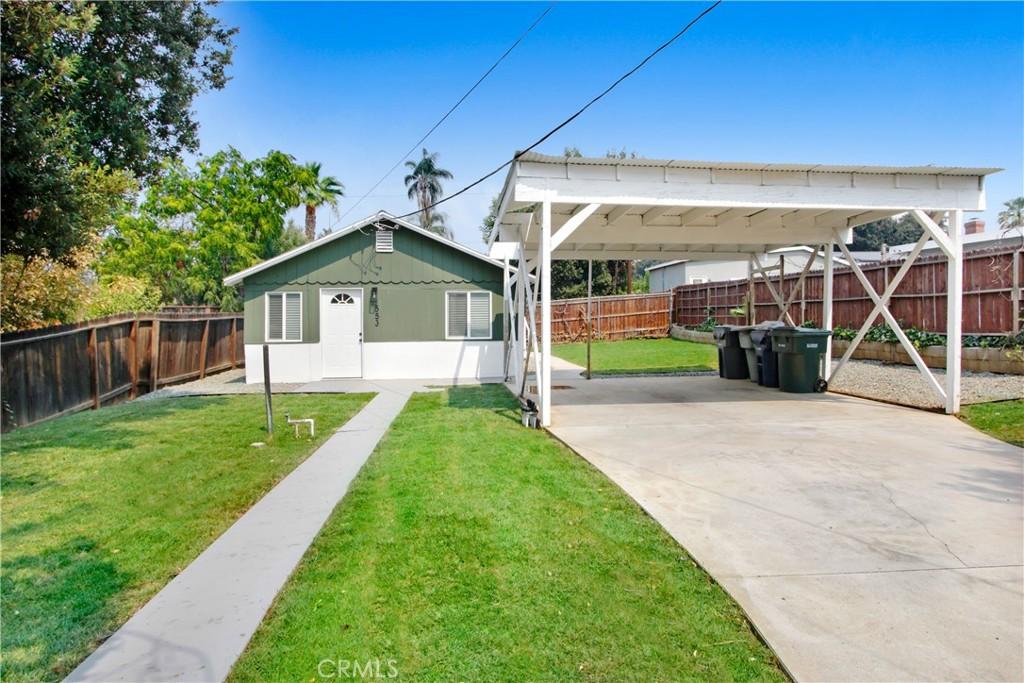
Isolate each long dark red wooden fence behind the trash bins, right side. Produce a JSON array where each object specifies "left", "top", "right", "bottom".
[{"left": 673, "top": 248, "right": 1024, "bottom": 334}]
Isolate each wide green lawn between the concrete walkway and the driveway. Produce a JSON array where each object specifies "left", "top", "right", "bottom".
[{"left": 231, "top": 386, "right": 783, "bottom": 681}]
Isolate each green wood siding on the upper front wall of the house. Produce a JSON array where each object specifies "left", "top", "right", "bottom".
[{"left": 243, "top": 226, "right": 503, "bottom": 344}]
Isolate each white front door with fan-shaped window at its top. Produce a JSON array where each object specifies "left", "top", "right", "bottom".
[{"left": 321, "top": 289, "right": 362, "bottom": 377}]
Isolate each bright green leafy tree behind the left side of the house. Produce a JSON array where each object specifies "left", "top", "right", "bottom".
[{"left": 100, "top": 147, "right": 306, "bottom": 310}]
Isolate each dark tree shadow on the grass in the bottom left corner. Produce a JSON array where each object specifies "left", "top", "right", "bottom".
[{"left": 0, "top": 537, "right": 130, "bottom": 680}]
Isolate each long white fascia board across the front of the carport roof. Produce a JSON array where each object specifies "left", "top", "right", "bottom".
[{"left": 515, "top": 177, "right": 985, "bottom": 213}]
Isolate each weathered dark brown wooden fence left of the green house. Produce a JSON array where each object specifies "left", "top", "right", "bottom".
[{"left": 0, "top": 311, "right": 245, "bottom": 431}]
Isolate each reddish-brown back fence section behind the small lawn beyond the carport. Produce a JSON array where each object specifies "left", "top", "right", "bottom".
[{"left": 537, "top": 292, "right": 672, "bottom": 344}]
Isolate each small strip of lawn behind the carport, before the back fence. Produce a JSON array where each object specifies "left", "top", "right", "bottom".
[{"left": 552, "top": 337, "right": 718, "bottom": 375}]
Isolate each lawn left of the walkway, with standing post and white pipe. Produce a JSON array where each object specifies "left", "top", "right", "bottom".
[{"left": 0, "top": 394, "right": 370, "bottom": 681}]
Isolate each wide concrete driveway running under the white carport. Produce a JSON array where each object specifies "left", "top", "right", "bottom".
[{"left": 552, "top": 373, "right": 1024, "bottom": 681}]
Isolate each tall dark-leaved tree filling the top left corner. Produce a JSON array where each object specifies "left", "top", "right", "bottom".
[{"left": 0, "top": 0, "right": 234, "bottom": 265}]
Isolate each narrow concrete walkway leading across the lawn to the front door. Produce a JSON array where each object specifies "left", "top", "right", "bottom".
[{"left": 69, "top": 380, "right": 415, "bottom": 681}]
